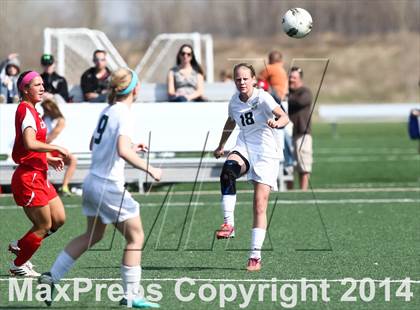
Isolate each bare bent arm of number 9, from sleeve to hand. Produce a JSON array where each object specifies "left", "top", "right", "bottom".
[{"left": 117, "top": 135, "right": 162, "bottom": 181}]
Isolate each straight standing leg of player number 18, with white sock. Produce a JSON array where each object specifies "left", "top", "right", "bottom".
[{"left": 247, "top": 182, "right": 271, "bottom": 271}]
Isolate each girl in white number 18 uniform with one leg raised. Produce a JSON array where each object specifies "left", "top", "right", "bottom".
[{"left": 214, "top": 63, "right": 289, "bottom": 271}]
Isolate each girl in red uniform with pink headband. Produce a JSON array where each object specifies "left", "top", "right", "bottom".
[{"left": 9, "top": 71, "right": 68, "bottom": 277}]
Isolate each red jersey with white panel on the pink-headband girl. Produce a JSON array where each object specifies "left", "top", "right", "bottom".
[{"left": 12, "top": 101, "right": 48, "bottom": 171}]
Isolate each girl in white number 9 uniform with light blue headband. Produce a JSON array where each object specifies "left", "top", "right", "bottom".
[{"left": 39, "top": 69, "right": 162, "bottom": 308}]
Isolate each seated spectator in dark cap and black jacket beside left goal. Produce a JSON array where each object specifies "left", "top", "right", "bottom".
[{"left": 41, "top": 54, "right": 69, "bottom": 102}]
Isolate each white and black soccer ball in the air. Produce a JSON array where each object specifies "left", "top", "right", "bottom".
[{"left": 281, "top": 8, "right": 312, "bottom": 39}]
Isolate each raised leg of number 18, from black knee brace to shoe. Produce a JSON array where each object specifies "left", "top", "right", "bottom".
[{"left": 216, "top": 152, "right": 247, "bottom": 239}]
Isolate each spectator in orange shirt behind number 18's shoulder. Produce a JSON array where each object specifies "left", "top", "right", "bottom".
[{"left": 258, "top": 51, "right": 288, "bottom": 103}]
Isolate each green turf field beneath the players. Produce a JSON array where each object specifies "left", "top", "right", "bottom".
[{"left": 0, "top": 124, "right": 420, "bottom": 310}]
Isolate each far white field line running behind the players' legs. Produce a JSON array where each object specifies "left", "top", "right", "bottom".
[{"left": 0, "top": 198, "right": 420, "bottom": 210}]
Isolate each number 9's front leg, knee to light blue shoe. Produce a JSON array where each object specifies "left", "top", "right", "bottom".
[{"left": 115, "top": 216, "right": 160, "bottom": 308}]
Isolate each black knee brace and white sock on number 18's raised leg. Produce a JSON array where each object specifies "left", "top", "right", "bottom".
[{"left": 220, "top": 160, "right": 241, "bottom": 226}]
